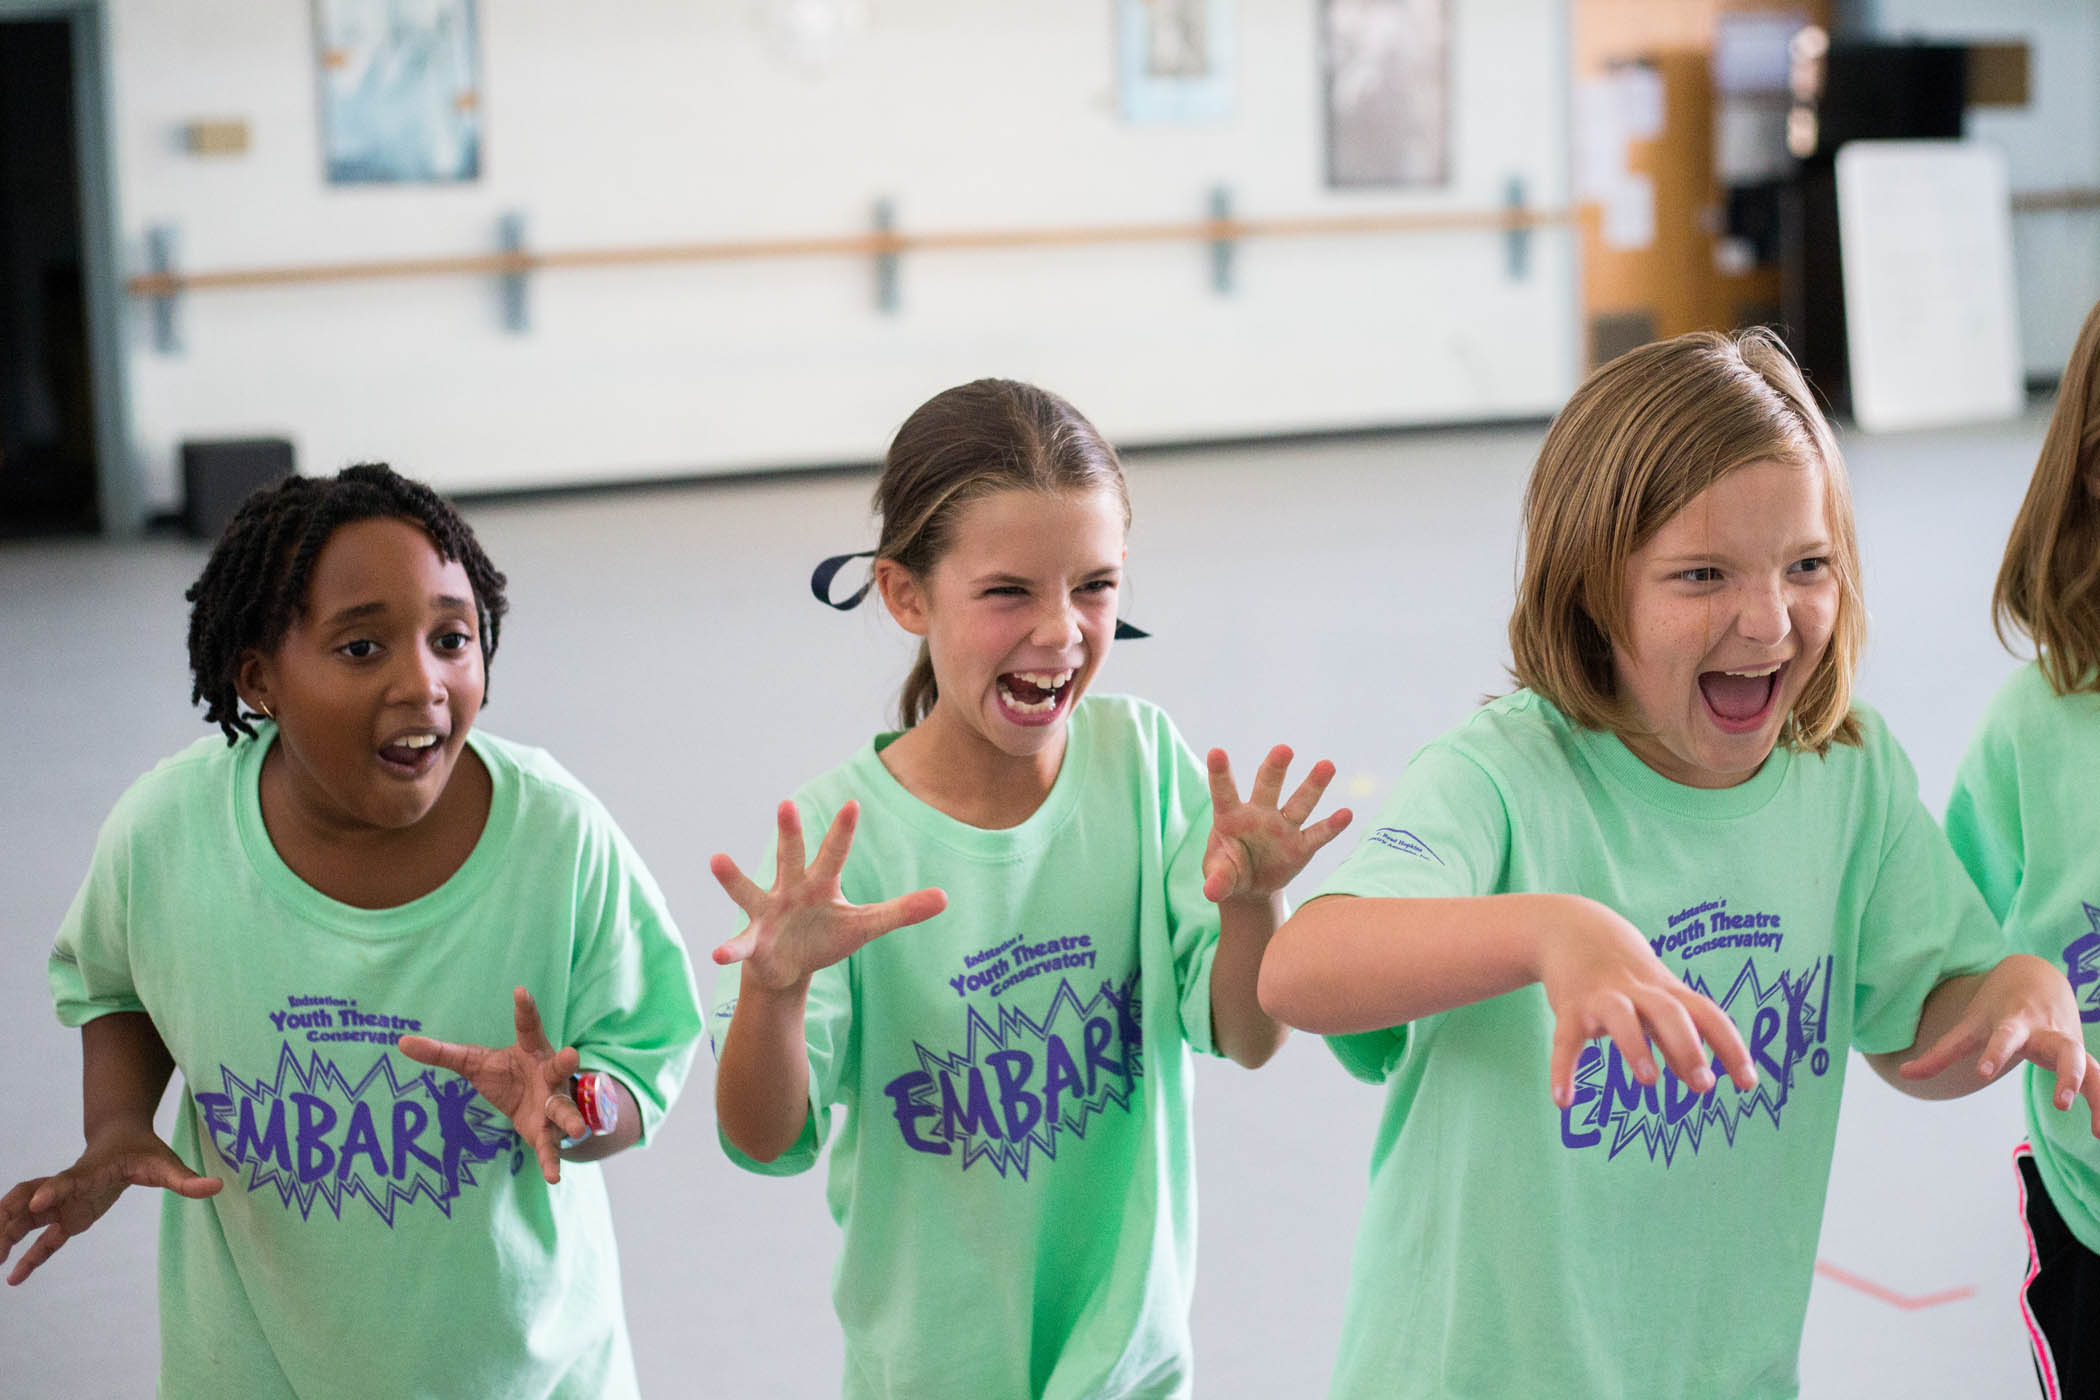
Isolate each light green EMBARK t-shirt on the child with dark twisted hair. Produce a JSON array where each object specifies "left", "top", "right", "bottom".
[{"left": 50, "top": 726, "right": 704, "bottom": 1400}]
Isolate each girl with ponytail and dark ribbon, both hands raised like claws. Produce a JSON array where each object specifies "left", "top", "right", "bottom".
[{"left": 714, "top": 380, "right": 1348, "bottom": 1400}]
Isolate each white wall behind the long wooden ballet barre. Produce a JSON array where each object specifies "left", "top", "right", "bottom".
[{"left": 109, "top": 0, "right": 1575, "bottom": 506}]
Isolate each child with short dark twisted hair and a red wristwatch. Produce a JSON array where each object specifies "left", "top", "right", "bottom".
[{"left": 0, "top": 466, "right": 704, "bottom": 1400}]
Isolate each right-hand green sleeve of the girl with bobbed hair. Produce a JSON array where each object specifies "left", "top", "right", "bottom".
[{"left": 1852, "top": 739, "right": 2006, "bottom": 1054}]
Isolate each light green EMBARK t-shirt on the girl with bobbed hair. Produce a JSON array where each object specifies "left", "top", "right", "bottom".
[{"left": 1321, "top": 691, "right": 2001, "bottom": 1400}]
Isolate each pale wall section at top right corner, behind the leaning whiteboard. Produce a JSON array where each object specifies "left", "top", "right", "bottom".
[{"left": 1859, "top": 0, "right": 2100, "bottom": 376}]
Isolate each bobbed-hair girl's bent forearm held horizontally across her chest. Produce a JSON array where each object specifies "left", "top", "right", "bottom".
[{"left": 1260, "top": 894, "right": 1596, "bottom": 1035}]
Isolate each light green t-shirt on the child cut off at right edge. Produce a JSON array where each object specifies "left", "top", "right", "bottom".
[{"left": 1947, "top": 665, "right": 2100, "bottom": 1250}]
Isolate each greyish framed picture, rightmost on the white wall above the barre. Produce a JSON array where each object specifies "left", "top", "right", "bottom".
[{"left": 1321, "top": 0, "right": 1451, "bottom": 189}]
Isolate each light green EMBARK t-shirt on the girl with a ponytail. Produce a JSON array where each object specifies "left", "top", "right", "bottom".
[{"left": 710, "top": 697, "right": 1218, "bottom": 1400}]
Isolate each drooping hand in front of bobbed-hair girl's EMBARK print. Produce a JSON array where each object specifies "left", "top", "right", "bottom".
[{"left": 1539, "top": 900, "right": 1758, "bottom": 1108}]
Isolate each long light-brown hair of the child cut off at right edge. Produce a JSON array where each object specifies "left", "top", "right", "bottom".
[{"left": 1991, "top": 295, "right": 2100, "bottom": 695}]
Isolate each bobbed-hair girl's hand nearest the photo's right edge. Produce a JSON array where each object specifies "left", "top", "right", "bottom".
[{"left": 1898, "top": 953, "right": 2100, "bottom": 1138}]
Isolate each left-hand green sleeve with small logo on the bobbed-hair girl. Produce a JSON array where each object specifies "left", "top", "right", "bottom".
[{"left": 1317, "top": 743, "right": 1510, "bottom": 1083}]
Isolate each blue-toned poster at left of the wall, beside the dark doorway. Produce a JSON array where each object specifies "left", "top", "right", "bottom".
[{"left": 313, "top": 0, "right": 481, "bottom": 185}]
